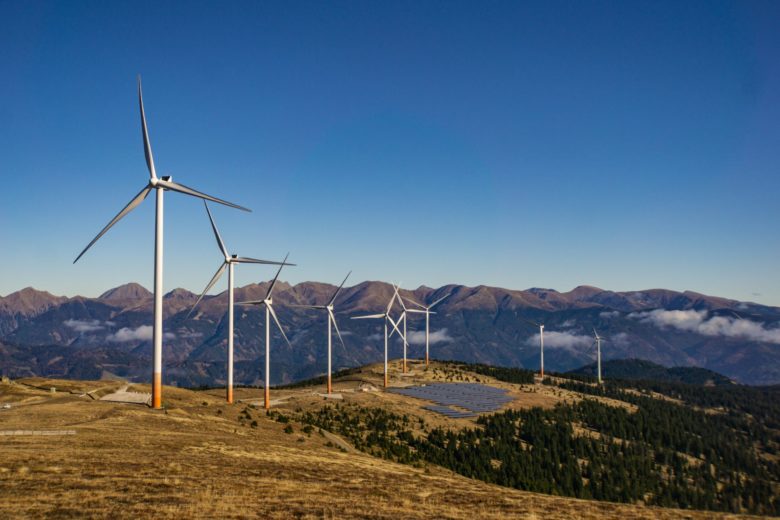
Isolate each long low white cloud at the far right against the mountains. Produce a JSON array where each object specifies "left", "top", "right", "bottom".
[{"left": 628, "top": 309, "right": 780, "bottom": 344}]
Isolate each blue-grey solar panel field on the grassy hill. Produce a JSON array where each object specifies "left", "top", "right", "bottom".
[{"left": 389, "top": 383, "right": 512, "bottom": 418}]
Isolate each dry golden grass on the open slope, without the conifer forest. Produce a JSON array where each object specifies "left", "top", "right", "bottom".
[{"left": 0, "top": 364, "right": 760, "bottom": 520}]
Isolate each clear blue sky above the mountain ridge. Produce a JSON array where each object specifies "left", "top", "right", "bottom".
[{"left": 0, "top": 1, "right": 780, "bottom": 305}]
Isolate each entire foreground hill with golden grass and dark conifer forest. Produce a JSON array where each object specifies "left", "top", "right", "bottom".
[{"left": 0, "top": 362, "right": 778, "bottom": 519}]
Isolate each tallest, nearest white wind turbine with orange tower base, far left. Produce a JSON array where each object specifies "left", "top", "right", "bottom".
[{"left": 73, "top": 76, "right": 251, "bottom": 409}]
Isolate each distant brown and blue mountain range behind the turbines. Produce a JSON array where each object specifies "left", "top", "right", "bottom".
[{"left": 0, "top": 281, "right": 780, "bottom": 386}]
